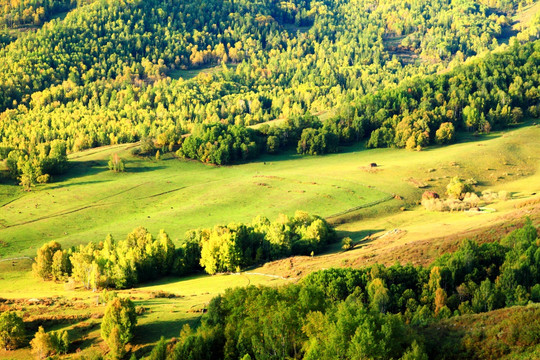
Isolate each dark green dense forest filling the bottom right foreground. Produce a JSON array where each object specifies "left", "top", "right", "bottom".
[{"left": 150, "top": 221, "right": 540, "bottom": 360}]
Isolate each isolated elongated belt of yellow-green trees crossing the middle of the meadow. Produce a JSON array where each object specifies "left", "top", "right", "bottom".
[{"left": 32, "top": 211, "right": 335, "bottom": 289}]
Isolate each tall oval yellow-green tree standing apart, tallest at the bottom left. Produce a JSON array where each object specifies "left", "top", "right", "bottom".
[{"left": 101, "top": 298, "right": 137, "bottom": 359}]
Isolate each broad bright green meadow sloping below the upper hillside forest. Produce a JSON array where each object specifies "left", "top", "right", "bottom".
[{"left": 0, "top": 126, "right": 540, "bottom": 258}]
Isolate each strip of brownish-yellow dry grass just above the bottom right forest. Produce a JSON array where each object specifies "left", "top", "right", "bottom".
[{"left": 254, "top": 198, "right": 540, "bottom": 278}]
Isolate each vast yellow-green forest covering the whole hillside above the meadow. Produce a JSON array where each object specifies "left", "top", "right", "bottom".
[{"left": 0, "top": 0, "right": 540, "bottom": 185}]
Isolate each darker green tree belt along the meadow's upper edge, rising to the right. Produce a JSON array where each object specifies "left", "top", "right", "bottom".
[{"left": 0, "top": 36, "right": 540, "bottom": 183}]
